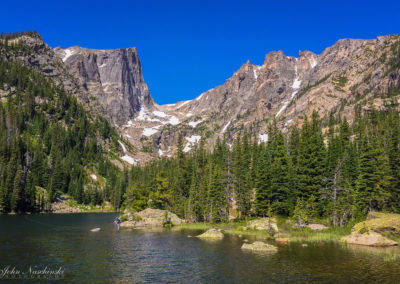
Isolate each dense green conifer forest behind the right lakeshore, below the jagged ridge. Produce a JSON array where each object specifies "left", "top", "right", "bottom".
[{"left": 123, "top": 106, "right": 400, "bottom": 226}]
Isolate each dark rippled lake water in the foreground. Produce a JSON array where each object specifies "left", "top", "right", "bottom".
[{"left": 0, "top": 213, "right": 400, "bottom": 283}]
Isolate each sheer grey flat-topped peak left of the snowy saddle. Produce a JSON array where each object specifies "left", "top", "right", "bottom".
[{"left": 54, "top": 46, "right": 154, "bottom": 126}]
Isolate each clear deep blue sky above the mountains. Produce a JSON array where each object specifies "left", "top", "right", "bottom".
[{"left": 0, "top": 0, "right": 400, "bottom": 104}]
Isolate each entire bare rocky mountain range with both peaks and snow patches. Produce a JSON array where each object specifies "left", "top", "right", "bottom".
[{"left": 4, "top": 32, "right": 400, "bottom": 164}]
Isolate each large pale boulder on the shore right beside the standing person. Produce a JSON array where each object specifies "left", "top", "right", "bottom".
[{"left": 121, "top": 208, "right": 182, "bottom": 229}]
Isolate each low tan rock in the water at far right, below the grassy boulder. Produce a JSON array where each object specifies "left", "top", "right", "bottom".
[{"left": 341, "top": 232, "right": 397, "bottom": 247}]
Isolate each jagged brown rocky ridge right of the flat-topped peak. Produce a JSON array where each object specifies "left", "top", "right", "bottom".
[{"left": 128, "top": 35, "right": 400, "bottom": 159}]
